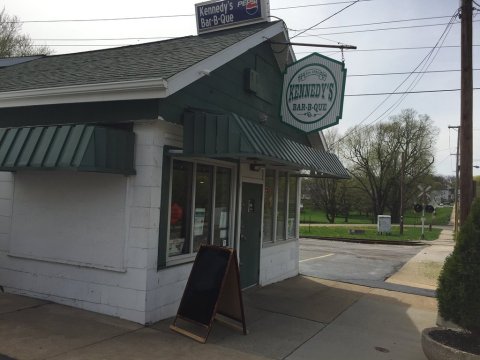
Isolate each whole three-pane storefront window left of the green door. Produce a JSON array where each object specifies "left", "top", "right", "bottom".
[{"left": 167, "top": 159, "right": 233, "bottom": 258}]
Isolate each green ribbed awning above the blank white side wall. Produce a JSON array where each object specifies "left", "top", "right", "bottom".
[{"left": 0, "top": 125, "right": 135, "bottom": 175}]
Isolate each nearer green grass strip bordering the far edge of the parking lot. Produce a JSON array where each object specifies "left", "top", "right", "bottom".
[{"left": 300, "top": 226, "right": 441, "bottom": 241}]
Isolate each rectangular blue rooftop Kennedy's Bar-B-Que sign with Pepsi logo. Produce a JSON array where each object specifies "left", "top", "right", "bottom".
[{"left": 195, "top": 0, "right": 270, "bottom": 34}]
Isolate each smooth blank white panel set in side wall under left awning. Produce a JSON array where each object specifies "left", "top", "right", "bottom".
[{"left": 9, "top": 171, "right": 127, "bottom": 271}]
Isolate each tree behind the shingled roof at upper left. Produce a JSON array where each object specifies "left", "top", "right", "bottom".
[{"left": 0, "top": 9, "right": 52, "bottom": 57}]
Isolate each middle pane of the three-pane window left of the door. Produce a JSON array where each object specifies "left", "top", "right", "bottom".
[{"left": 193, "top": 164, "right": 213, "bottom": 252}]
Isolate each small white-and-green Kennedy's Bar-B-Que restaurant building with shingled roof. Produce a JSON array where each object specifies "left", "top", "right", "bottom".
[{"left": 0, "top": 1, "right": 348, "bottom": 324}]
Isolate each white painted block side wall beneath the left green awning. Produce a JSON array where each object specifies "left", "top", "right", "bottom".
[{"left": 0, "top": 120, "right": 176, "bottom": 323}]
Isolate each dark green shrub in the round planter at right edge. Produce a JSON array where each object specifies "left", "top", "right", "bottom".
[{"left": 437, "top": 199, "right": 480, "bottom": 336}]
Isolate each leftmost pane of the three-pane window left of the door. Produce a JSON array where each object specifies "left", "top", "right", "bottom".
[{"left": 168, "top": 160, "right": 193, "bottom": 256}]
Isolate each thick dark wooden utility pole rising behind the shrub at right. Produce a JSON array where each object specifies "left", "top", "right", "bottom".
[{"left": 460, "top": 0, "right": 473, "bottom": 225}]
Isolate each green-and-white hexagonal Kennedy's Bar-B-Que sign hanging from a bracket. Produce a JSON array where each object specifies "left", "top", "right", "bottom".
[{"left": 280, "top": 53, "right": 347, "bottom": 133}]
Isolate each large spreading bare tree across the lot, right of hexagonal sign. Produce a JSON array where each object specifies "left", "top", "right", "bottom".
[{"left": 342, "top": 109, "right": 438, "bottom": 221}]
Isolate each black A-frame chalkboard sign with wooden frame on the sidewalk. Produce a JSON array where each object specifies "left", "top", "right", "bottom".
[{"left": 170, "top": 245, "right": 247, "bottom": 343}]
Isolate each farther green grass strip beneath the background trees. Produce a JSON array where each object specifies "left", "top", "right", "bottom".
[{"left": 300, "top": 207, "right": 452, "bottom": 225}]
